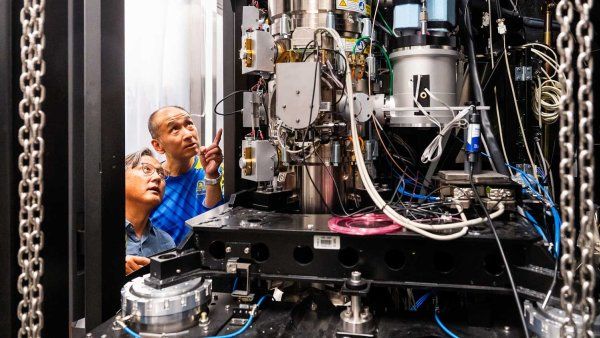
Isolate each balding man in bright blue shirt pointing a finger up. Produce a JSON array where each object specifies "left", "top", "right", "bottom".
[{"left": 148, "top": 106, "right": 223, "bottom": 245}]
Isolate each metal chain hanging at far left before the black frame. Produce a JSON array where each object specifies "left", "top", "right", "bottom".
[{"left": 17, "top": 0, "right": 46, "bottom": 337}]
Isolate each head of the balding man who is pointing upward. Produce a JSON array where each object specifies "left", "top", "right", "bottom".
[{"left": 154, "top": 108, "right": 199, "bottom": 159}]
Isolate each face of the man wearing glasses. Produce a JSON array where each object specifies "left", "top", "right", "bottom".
[{"left": 125, "top": 156, "right": 165, "bottom": 208}]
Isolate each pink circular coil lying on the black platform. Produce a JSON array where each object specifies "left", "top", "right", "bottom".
[{"left": 328, "top": 214, "right": 402, "bottom": 236}]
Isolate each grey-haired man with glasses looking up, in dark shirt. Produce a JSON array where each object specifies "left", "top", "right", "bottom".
[{"left": 125, "top": 148, "right": 175, "bottom": 274}]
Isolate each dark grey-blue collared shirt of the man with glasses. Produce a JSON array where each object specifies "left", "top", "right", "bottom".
[{"left": 125, "top": 220, "right": 175, "bottom": 257}]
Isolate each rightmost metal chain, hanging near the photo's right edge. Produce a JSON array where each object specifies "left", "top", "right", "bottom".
[{"left": 575, "top": 0, "right": 596, "bottom": 337}]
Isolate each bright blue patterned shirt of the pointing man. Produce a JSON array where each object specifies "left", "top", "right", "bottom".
[{"left": 150, "top": 156, "right": 223, "bottom": 245}]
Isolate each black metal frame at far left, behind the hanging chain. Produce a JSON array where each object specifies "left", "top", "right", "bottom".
[{"left": 0, "top": 0, "right": 125, "bottom": 337}]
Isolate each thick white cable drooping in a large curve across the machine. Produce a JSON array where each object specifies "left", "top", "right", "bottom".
[{"left": 321, "top": 28, "right": 504, "bottom": 241}]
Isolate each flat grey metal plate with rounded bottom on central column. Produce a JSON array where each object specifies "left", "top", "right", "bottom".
[{"left": 275, "top": 61, "right": 321, "bottom": 129}]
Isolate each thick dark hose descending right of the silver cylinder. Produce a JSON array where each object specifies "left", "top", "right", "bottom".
[{"left": 463, "top": 0, "right": 510, "bottom": 176}]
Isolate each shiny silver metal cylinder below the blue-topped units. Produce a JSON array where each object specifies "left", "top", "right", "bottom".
[{"left": 390, "top": 47, "right": 458, "bottom": 127}]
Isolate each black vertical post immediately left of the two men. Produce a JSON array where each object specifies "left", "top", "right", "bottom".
[{"left": 83, "top": 0, "right": 125, "bottom": 331}]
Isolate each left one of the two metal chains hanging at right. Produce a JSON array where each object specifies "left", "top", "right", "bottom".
[{"left": 556, "top": 0, "right": 577, "bottom": 337}]
